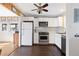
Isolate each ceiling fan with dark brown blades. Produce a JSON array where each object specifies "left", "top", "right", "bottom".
[{"left": 32, "top": 3, "right": 48, "bottom": 14}]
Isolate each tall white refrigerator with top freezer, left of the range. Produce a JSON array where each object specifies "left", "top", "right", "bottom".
[{"left": 21, "top": 21, "right": 33, "bottom": 45}]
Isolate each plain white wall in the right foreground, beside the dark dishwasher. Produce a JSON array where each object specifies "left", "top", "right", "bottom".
[{"left": 66, "top": 3, "right": 79, "bottom": 56}]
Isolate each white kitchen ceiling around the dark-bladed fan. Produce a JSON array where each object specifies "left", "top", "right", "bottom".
[{"left": 15, "top": 3, "right": 66, "bottom": 17}]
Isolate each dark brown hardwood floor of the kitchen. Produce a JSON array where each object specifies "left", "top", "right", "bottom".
[{"left": 10, "top": 45, "right": 63, "bottom": 56}]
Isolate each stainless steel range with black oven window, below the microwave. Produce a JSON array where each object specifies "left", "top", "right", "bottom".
[{"left": 39, "top": 32, "right": 49, "bottom": 44}]
